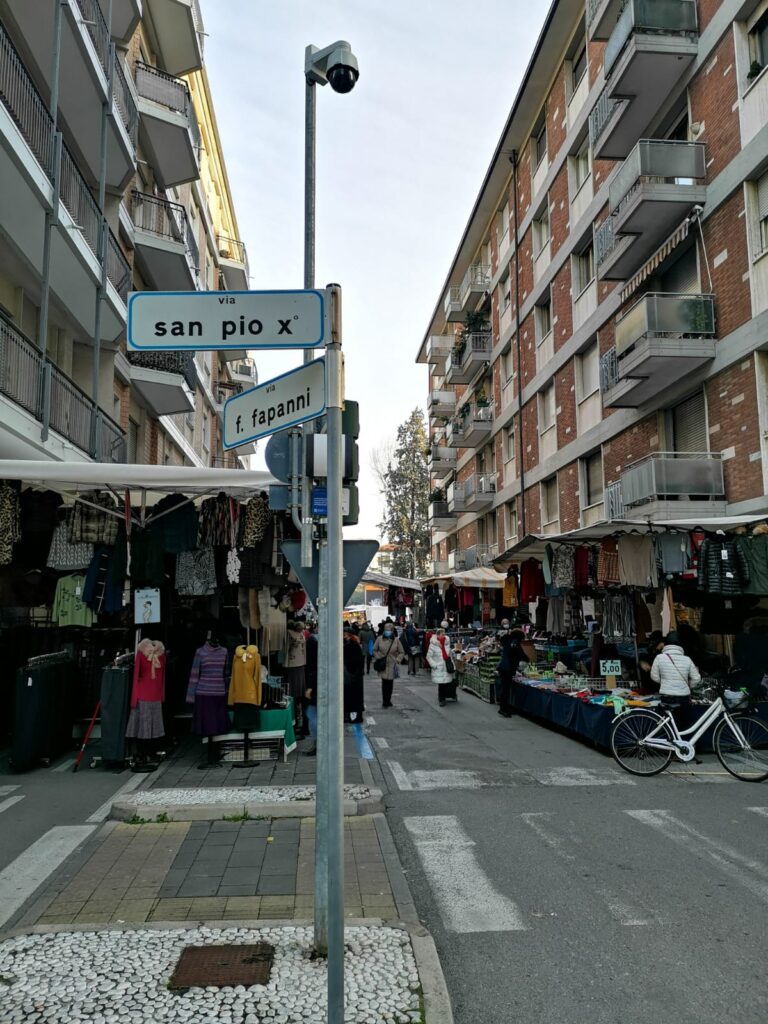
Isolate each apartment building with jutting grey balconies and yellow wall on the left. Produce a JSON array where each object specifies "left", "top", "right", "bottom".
[{"left": 0, "top": 0, "right": 256, "bottom": 466}]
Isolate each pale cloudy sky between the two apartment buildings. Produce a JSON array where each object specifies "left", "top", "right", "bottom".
[{"left": 201, "top": 0, "right": 549, "bottom": 540}]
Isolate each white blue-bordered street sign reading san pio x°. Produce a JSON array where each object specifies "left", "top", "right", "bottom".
[{"left": 127, "top": 290, "right": 328, "bottom": 352}]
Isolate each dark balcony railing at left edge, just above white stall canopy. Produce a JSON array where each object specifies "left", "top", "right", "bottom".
[{"left": 0, "top": 319, "right": 126, "bottom": 462}]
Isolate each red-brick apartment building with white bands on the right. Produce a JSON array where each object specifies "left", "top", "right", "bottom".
[{"left": 417, "top": 0, "right": 768, "bottom": 573}]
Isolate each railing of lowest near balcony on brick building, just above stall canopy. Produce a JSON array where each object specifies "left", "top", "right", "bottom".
[{"left": 622, "top": 452, "right": 725, "bottom": 508}]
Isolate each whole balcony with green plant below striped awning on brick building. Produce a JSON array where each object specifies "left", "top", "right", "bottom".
[{"left": 603, "top": 292, "right": 715, "bottom": 409}]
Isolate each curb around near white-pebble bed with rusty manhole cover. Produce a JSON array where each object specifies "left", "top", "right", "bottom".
[{"left": 2, "top": 918, "right": 454, "bottom": 1024}]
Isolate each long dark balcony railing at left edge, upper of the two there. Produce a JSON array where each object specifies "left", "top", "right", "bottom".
[{"left": 0, "top": 26, "right": 131, "bottom": 301}]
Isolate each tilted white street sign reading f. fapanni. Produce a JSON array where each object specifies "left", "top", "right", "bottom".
[{"left": 222, "top": 359, "right": 326, "bottom": 449}]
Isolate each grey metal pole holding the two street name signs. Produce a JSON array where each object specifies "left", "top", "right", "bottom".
[{"left": 325, "top": 285, "right": 344, "bottom": 1024}]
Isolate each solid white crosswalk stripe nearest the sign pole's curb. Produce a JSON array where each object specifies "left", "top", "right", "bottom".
[{"left": 404, "top": 815, "right": 526, "bottom": 934}]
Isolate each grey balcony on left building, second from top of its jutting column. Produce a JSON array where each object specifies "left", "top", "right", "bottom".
[{"left": 134, "top": 60, "right": 200, "bottom": 188}]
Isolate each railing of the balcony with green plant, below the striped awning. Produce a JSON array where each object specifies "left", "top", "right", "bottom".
[{"left": 615, "top": 292, "right": 715, "bottom": 355}]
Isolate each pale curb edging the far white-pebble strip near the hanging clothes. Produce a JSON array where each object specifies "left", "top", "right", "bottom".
[{"left": 110, "top": 790, "right": 384, "bottom": 822}]
